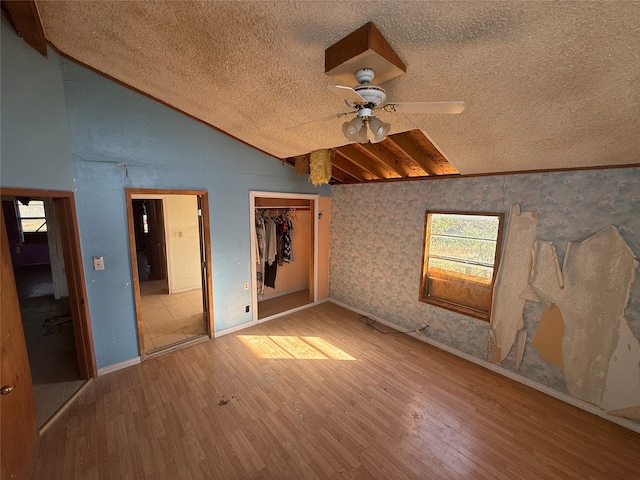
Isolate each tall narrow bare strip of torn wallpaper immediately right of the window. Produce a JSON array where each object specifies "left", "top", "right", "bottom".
[{"left": 487, "top": 205, "right": 538, "bottom": 364}]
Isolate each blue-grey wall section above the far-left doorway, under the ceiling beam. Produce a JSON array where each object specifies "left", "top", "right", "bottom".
[{"left": 0, "top": 17, "right": 73, "bottom": 190}]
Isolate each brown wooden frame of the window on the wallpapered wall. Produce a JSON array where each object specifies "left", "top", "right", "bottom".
[{"left": 418, "top": 210, "right": 505, "bottom": 322}]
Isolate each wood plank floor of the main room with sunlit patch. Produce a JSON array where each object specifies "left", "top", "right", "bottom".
[{"left": 33, "top": 303, "right": 640, "bottom": 480}]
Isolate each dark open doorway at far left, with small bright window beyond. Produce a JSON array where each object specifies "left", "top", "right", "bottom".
[{"left": 2, "top": 189, "right": 96, "bottom": 428}]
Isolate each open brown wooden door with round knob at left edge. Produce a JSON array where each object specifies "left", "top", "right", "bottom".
[{"left": 0, "top": 208, "right": 40, "bottom": 478}]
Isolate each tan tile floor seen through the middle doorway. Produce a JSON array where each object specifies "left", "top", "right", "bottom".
[{"left": 140, "top": 280, "right": 207, "bottom": 353}]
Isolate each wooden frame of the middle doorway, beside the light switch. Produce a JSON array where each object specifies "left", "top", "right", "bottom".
[{"left": 125, "top": 188, "right": 214, "bottom": 361}]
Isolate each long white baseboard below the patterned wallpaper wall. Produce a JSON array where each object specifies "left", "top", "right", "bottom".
[{"left": 329, "top": 298, "right": 640, "bottom": 433}]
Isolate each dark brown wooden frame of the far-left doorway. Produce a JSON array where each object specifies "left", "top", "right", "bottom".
[{"left": 0, "top": 187, "right": 98, "bottom": 379}]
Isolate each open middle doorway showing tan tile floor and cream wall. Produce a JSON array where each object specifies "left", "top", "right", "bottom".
[{"left": 127, "top": 189, "right": 213, "bottom": 358}]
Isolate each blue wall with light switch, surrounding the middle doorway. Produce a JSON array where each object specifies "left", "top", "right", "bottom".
[{"left": 62, "top": 60, "right": 329, "bottom": 367}]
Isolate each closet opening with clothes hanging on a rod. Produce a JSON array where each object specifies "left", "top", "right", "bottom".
[{"left": 251, "top": 192, "right": 318, "bottom": 322}]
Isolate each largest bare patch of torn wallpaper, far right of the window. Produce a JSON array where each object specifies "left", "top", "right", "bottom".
[{"left": 531, "top": 226, "right": 637, "bottom": 405}]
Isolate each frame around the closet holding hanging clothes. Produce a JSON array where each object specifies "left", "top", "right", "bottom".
[{"left": 249, "top": 190, "right": 320, "bottom": 325}]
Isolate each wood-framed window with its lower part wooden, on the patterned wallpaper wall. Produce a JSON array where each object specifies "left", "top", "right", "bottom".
[{"left": 420, "top": 212, "right": 504, "bottom": 321}]
